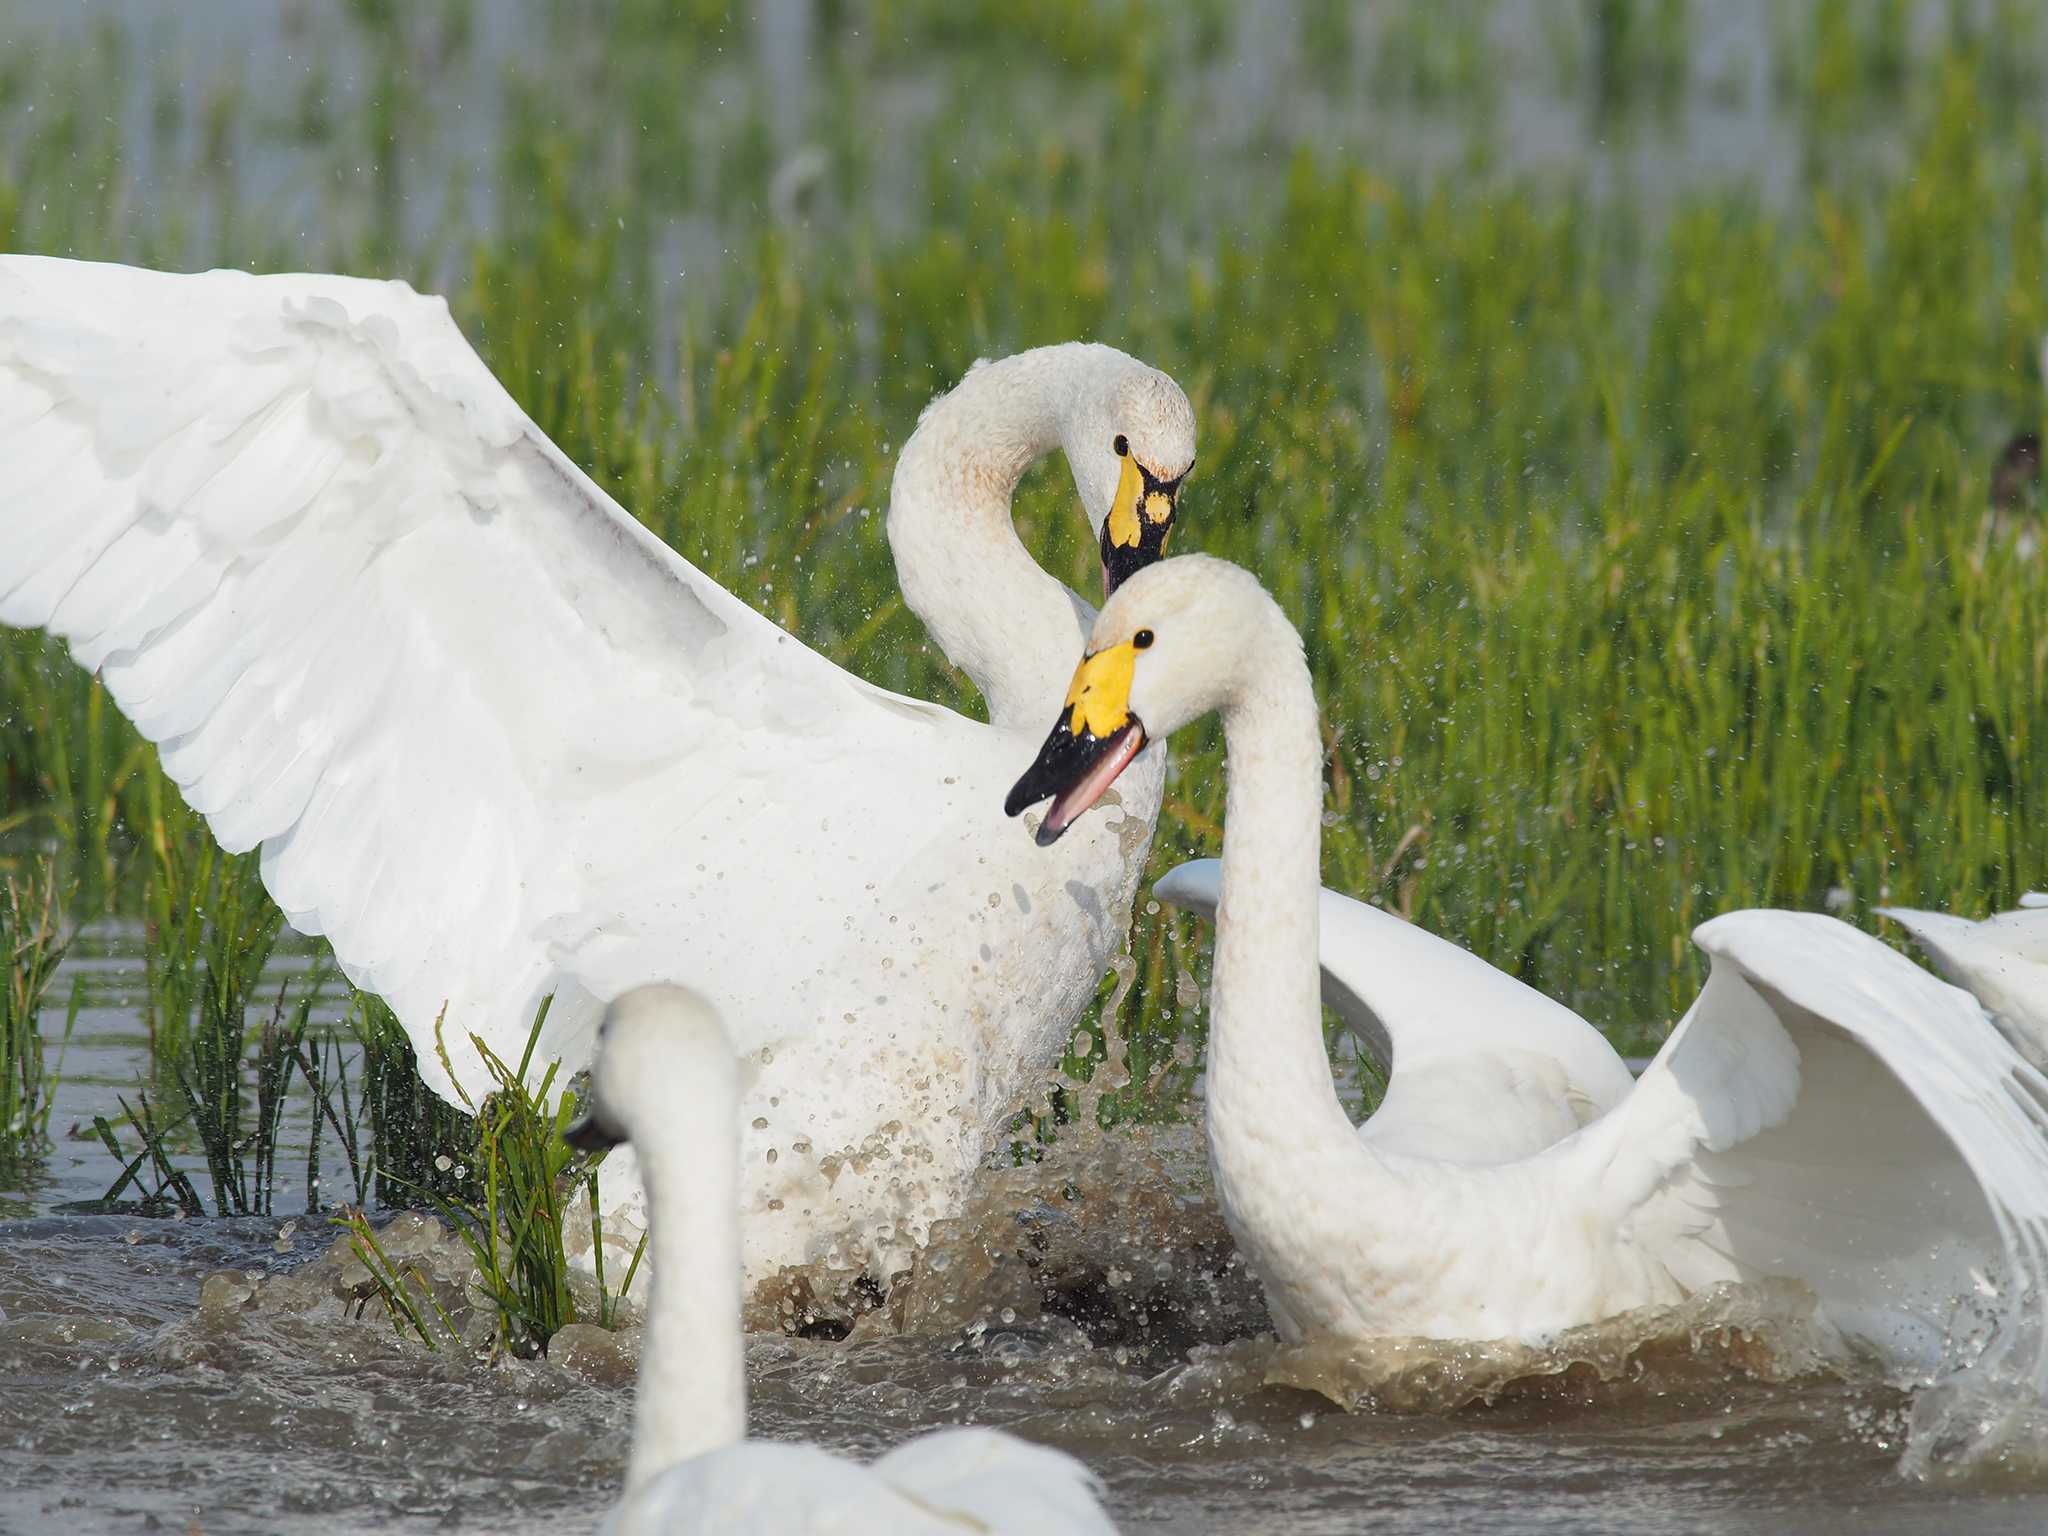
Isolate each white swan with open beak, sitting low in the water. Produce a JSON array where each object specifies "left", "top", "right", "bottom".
[{"left": 1008, "top": 555, "right": 2048, "bottom": 1449}]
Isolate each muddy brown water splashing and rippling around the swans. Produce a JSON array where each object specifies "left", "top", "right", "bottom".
[{"left": 0, "top": 926, "right": 2048, "bottom": 1534}]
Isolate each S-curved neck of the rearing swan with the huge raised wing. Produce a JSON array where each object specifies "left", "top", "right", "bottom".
[{"left": 889, "top": 346, "right": 1096, "bottom": 729}]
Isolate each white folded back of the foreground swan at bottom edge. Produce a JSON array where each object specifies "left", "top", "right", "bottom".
[{"left": 604, "top": 1430, "right": 1116, "bottom": 1536}]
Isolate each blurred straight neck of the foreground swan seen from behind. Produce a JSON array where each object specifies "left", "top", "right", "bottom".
[{"left": 627, "top": 1038, "right": 748, "bottom": 1493}]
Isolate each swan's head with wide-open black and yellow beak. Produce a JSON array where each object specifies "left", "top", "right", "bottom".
[{"left": 1004, "top": 555, "right": 1300, "bottom": 846}]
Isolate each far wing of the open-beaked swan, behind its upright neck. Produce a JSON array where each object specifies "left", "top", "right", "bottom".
[{"left": 1153, "top": 858, "right": 1632, "bottom": 1163}]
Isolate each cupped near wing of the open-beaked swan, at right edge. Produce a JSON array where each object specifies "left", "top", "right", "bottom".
[{"left": 1554, "top": 911, "right": 2048, "bottom": 1441}]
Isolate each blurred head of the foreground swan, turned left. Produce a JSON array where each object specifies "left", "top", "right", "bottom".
[{"left": 561, "top": 987, "right": 737, "bottom": 1151}]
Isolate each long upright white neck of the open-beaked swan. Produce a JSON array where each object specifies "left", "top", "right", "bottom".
[{"left": 1208, "top": 633, "right": 1374, "bottom": 1335}]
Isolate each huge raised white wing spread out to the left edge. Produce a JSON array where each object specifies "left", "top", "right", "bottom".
[{"left": 0, "top": 256, "right": 952, "bottom": 1092}]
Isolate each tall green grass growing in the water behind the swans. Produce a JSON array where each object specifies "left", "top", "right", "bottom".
[{"left": 0, "top": 0, "right": 2048, "bottom": 1114}]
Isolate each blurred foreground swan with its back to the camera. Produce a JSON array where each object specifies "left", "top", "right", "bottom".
[{"left": 569, "top": 987, "right": 1114, "bottom": 1536}]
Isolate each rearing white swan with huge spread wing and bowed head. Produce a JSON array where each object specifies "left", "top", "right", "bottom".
[{"left": 0, "top": 256, "right": 1194, "bottom": 1278}]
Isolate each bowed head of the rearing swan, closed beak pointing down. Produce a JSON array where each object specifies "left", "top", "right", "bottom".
[{"left": 1065, "top": 346, "right": 1194, "bottom": 598}]
